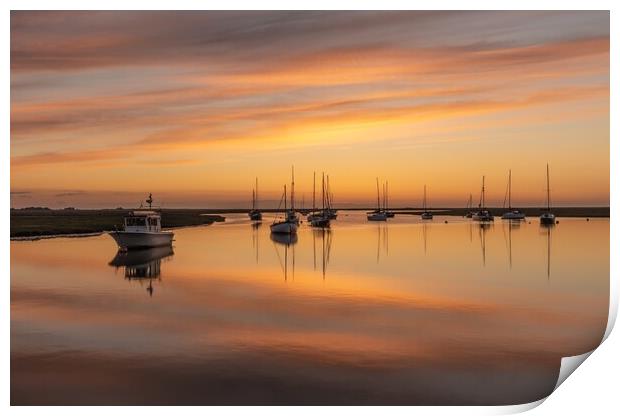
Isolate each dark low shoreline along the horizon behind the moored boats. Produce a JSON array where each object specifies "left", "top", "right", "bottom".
[{"left": 10, "top": 207, "right": 609, "bottom": 241}]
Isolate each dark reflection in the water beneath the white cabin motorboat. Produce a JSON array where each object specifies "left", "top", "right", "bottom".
[{"left": 108, "top": 246, "right": 174, "bottom": 296}]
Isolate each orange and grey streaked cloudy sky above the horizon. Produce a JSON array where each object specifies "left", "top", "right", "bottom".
[{"left": 11, "top": 11, "right": 609, "bottom": 208}]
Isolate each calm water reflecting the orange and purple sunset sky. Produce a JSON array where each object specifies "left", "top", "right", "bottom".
[{"left": 11, "top": 211, "right": 609, "bottom": 404}]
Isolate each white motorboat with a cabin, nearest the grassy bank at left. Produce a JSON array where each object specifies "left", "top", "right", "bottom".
[{"left": 109, "top": 194, "right": 174, "bottom": 250}]
